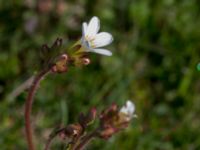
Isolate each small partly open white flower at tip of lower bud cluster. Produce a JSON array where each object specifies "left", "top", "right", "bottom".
[{"left": 120, "top": 100, "right": 136, "bottom": 121}]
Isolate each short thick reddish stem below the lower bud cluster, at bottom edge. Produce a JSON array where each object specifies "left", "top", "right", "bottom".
[{"left": 74, "top": 131, "right": 96, "bottom": 150}]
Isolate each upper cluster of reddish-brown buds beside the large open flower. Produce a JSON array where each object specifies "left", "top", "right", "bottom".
[{"left": 42, "top": 38, "right": 90, "bottom": 73}]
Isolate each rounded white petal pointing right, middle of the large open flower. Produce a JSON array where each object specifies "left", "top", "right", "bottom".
[{"left": 92, "top": 32, "right": 113, "bottom": 47}]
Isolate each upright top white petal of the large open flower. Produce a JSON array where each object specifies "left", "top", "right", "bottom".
[{"left": 86, "top": 17, "right": 100, "bottom": 38}]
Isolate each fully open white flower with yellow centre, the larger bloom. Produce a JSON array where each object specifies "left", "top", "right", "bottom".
[{"left": 81, "top": 17, "right": 113, "bottom": 56}]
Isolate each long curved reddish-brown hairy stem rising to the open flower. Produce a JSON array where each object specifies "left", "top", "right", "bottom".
[{"left": 25, "top": 70, "right": 50, "bottom": 150}]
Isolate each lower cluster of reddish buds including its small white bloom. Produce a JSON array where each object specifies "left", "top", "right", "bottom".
[{"left": 46, "top": 100, "right": 136, "bottom": 150}]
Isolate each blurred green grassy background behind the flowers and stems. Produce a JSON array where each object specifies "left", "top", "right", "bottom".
[{"left": 0, "top": 0, "right": 200, "bottom": 150}]
